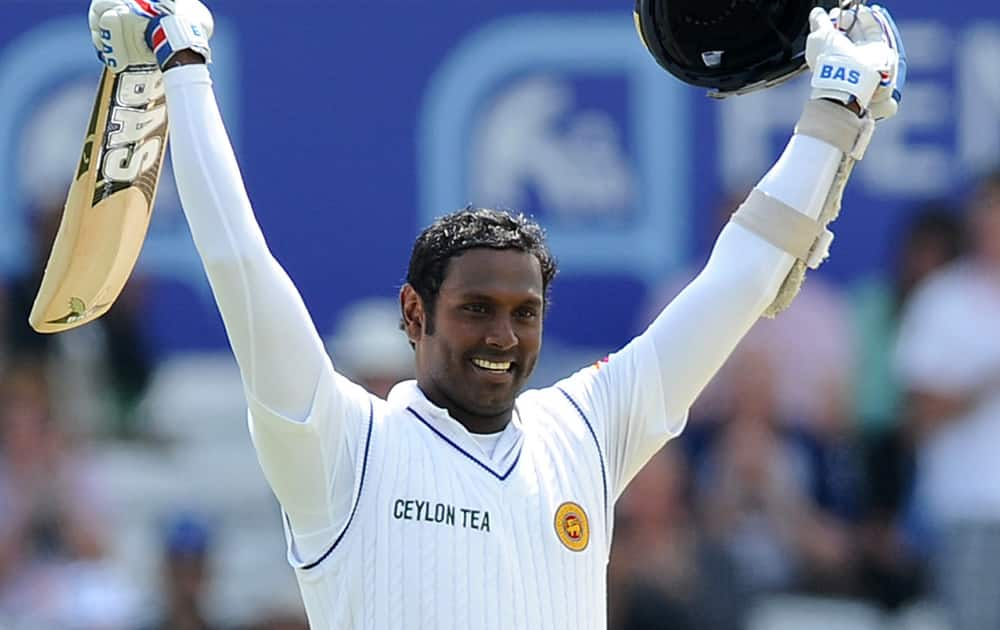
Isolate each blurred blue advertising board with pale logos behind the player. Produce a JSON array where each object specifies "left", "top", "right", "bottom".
[{"left": 0, "top": 0, "right": 1000, "bottom": 352}]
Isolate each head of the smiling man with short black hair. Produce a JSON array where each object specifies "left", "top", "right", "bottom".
[{"left": 400, "top": 220, "right": 556, "bottom": 435}]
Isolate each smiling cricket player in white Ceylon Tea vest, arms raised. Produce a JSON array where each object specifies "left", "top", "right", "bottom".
[{"left": 90, "top": 0, "right": 898, "bottom": 630}]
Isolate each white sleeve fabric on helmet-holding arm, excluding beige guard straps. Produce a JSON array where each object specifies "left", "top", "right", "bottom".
[{"left": 559, "top": 136, "right": 842, "bottom": 500}]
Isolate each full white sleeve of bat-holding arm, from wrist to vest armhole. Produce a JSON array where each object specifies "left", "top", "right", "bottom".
[{"left": 165, "top": 65, "right": 371, "bottom": 531}]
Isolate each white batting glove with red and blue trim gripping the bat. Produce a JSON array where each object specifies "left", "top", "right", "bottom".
[{"left": 88, "top": 0, "right": 214, "bottom": 72}]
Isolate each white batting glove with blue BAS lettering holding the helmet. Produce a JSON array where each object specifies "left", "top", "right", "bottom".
[{"left": 806, "top": 6, "right": 906, "bottom": 119}]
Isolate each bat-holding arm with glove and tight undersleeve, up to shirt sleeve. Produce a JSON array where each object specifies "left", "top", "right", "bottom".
[{"left": 90, "top": 0, "right": 326, "bottom": 419}]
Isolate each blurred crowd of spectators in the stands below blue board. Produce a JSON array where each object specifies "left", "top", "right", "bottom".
[{"left": 0, "top": 172, "right": 1000, "bottom": 630}]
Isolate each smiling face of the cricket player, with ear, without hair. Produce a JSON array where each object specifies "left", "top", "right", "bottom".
[{"left": 403, "top": 248, "right": 544, "bottom": 432}]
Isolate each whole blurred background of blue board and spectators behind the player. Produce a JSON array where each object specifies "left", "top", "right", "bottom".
[{"left": 0, "top": 0, "right": 1000, "bottom": 630}]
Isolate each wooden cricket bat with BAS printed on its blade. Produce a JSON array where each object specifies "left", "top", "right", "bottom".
[{"left": 28, "top": 66, "right": 167, "bottom": 333}]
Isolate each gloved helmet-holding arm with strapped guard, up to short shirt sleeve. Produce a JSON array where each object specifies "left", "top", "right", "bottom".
[{"left": 647, "top": 7, "right": 905, "bottom": 428}]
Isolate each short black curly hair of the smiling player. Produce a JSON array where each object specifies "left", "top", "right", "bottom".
[{"left": 406, "top": 206, "right": 556, "bottom": 334}]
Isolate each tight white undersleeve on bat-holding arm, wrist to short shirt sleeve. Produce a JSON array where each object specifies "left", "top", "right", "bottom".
[{"left": 159, "top": 56, "right": 327, "bottom": 419}]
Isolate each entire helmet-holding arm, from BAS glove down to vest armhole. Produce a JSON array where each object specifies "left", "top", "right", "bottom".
[{"left": 564, "top": 7, "right": 903, "bottom": 493}]
